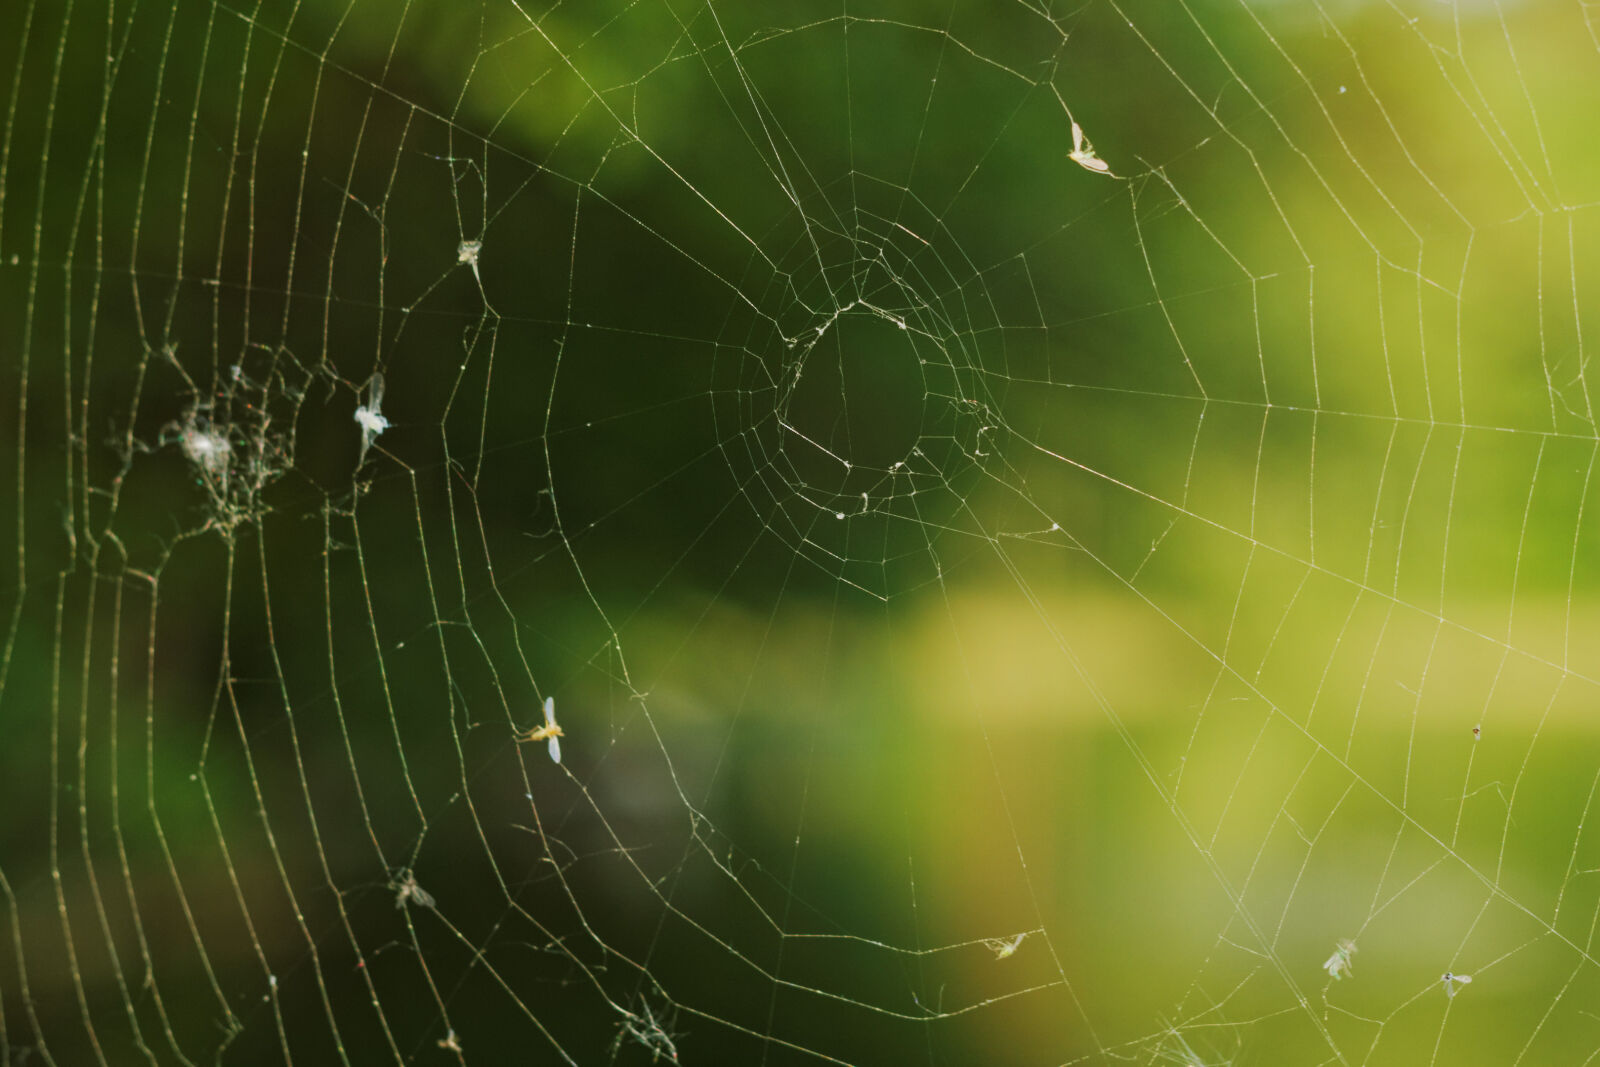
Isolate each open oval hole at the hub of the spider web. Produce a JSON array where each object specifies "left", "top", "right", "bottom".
[{"left": 784, "top": 309, "right": 926, "bottom": 486}]
